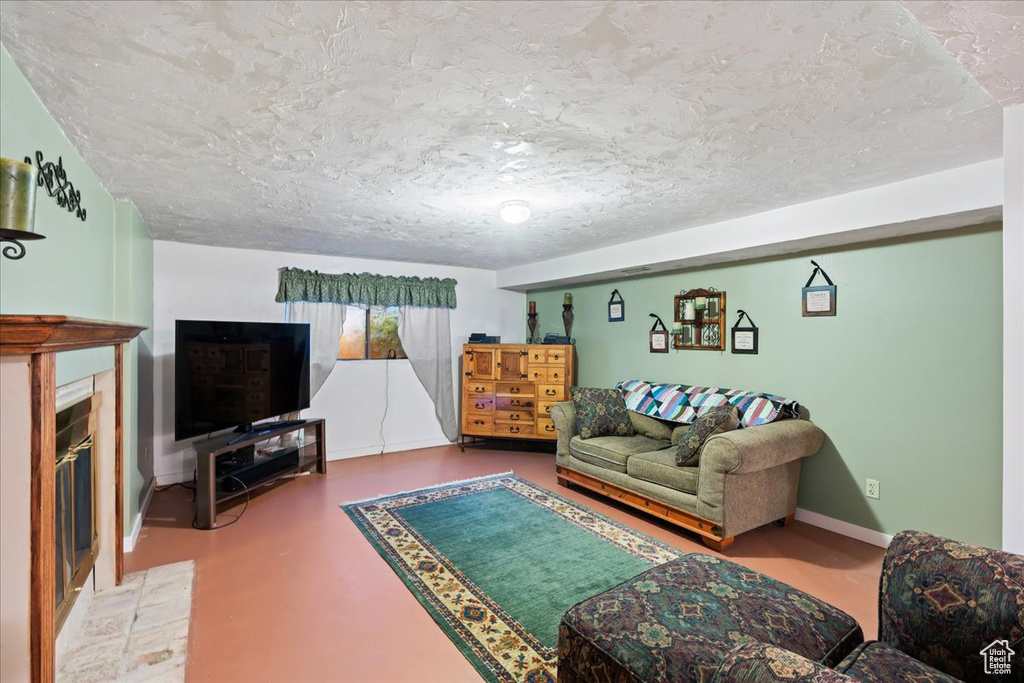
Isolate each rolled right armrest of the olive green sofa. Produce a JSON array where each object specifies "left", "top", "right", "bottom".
[{"left": 699, "top": 420, "right": 825, "bottom": 476}]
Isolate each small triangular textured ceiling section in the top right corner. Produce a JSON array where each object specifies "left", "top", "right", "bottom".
[{"left": 903, "top": 0, "right": 1024, "bottom": 106}]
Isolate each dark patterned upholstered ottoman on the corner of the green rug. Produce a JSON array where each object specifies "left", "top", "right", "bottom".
[{"left": 558, "top": 554, "right": 864, "bottom": 683}]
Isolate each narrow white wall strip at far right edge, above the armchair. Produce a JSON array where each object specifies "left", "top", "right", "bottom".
[{"left": 1002, "top": 104, "right": 1024, "bottom": 553}]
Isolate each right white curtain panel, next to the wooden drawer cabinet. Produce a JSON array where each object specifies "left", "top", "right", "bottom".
[{"left": 398, "top": 306, "right": 459, "bottom": 441}]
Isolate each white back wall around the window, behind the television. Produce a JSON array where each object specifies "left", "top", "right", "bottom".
[{"left": 154, "top": 241, "right": 525, "bottom": 484}]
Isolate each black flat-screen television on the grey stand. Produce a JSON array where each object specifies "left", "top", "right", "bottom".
[{"left": 174, "top": 321, "right": 309, "bottom": 440}]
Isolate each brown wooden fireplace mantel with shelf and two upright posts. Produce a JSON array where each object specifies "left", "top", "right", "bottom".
[{"left": 0, "top": 315, "right": 145, "bottom": 683}]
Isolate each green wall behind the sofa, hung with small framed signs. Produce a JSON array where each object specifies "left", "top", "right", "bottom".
[{"left": 527, "top": 224, "right": 1002, "bottom": 548}]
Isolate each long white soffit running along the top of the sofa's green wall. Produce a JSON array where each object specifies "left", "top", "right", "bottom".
[{"left": 498, "top": 159, "right": 1002, "bottom": 291}]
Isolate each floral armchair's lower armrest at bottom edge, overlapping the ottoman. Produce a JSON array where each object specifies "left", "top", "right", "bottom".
[{"left": 712, "top": 643, "right": 856, "bottom": 683}]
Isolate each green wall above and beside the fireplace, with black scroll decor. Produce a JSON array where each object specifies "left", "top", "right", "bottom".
[{"left": 0, "top": 46, "right": 153, "bottom": 531}]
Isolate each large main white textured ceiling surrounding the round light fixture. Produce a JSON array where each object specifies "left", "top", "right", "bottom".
[{"left": 0, "top": 0, "right": 1001, "bottom": 268}]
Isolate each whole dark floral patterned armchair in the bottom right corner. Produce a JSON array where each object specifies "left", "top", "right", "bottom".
[{"left": 714, "top": 531, "right": 1024, "bottom": 683}]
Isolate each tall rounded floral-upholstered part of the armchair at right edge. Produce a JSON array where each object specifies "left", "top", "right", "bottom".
[{"left": 879, "top": 531, "right": 1024, "bottom": 680}]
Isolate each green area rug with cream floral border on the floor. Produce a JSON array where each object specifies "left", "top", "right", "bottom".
[{"left": 343, "top": 473, "right": 680, "bottom": 683}]
